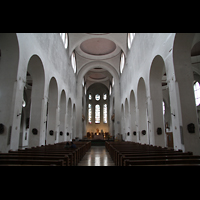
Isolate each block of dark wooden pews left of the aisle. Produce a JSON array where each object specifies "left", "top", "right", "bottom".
[{"left": 0, "top": 142, "right": 91, "bottom": 166}]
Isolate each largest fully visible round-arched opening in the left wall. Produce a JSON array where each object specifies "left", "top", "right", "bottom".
[{"left": 25, "top": 54, "right": 45, "bottom": 147}]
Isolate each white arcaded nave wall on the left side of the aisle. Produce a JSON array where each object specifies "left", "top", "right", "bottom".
[{"left": 0, "top": 33, "right": 76, "bottom": 152}]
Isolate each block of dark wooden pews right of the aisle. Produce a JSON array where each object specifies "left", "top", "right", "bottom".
[{"left": 106, "top": 142, "right": 200, "bottom": 166}]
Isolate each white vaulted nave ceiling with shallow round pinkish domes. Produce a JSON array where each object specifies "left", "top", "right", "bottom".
[{"left": 68, "top": 33, "right": 128, "bottom": 88}]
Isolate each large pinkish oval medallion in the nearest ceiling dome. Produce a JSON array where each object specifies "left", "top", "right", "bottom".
[{"left": 80, "top": 38, "right": 116, "bottom": 56}]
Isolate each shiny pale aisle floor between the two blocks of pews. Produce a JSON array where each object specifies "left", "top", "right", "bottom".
[{"left": 78, "top": 146, "right": 115, "bottom": 166}]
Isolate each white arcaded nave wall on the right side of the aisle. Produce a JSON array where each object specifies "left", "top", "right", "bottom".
[{"left": 119, "top": 33, "right": 200, "bottom": 154}]
